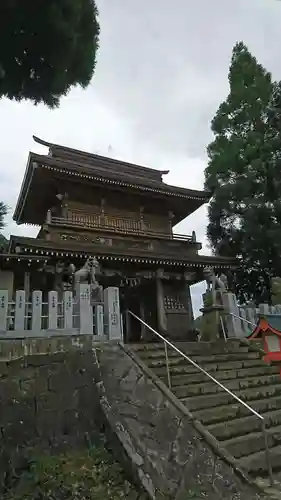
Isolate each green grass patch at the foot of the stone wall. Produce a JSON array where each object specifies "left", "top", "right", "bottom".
[{"left": 3, "top": 447, "right": 138, "bottom": 500}]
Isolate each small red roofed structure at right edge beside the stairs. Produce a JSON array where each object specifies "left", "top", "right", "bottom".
[{"left": 248, "top": 314, "right": 281, "bottom": 362}]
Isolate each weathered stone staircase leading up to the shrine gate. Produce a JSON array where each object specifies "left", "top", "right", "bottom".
[{"left": 130, "top": 340, "right": 281, "bottom": 488}]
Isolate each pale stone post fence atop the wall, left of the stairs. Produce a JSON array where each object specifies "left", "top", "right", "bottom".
[{"left": 0, "top": 284, "right": 122, "bottom": 340}]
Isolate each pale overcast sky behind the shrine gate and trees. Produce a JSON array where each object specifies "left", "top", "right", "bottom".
[{"left": 0, "top": 0, "right": 281, "bottom": 311}]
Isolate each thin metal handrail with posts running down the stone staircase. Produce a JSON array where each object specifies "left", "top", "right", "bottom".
[{"left": 128, "top": 310, "right": 274, "bottom": 486}]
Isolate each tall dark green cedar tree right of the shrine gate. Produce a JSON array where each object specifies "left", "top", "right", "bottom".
[{"left": 202, "top": 42, "right": 281, "bottom": 302}]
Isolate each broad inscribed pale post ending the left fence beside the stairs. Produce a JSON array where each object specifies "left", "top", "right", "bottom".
[{"left": 104, "top": 287, "right": 122, "bottom": 340}]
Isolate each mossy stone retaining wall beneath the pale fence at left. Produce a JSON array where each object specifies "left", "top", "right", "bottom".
[{"left": 0, "top": 338, "right": 97, "bottom": 488}]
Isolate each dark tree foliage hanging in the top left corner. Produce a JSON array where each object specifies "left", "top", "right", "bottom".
[{"left": 0, "top": 0, "right": 99, "bottom": 108}]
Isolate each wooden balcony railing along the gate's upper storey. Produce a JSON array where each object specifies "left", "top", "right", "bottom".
[{"left": 51, "top": 212, "right": 194, "bottom": 242}]
